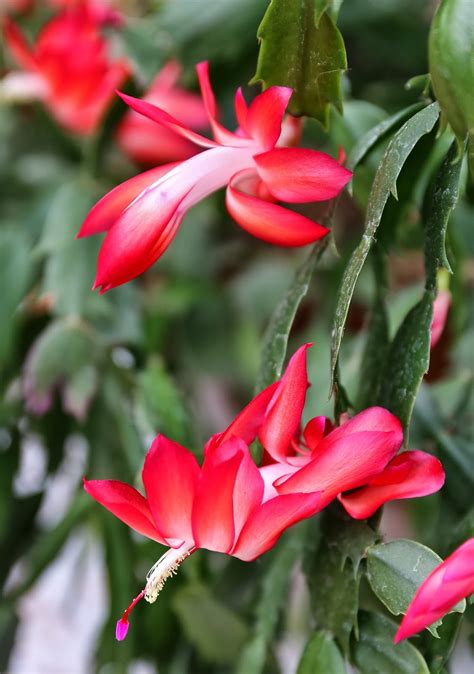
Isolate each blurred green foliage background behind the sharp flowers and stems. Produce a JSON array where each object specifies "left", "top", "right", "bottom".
[{"left": 0, "top": 0, "right": 474, "bottom": 674}]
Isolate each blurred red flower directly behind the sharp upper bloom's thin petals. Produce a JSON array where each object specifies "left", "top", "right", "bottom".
[{"left": 117, "top": 61, "right": 209, "bottom": 166}]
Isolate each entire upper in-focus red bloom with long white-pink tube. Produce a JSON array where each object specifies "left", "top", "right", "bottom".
[{"left": 78, "top": 62, "right": 351, "bottom": 292}]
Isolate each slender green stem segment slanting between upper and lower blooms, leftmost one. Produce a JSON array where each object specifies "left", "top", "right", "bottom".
[{"left": 255, "top": 237, "right": 328, "bottom": 391}]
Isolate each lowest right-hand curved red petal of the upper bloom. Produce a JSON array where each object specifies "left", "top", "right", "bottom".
[{"left": 226, "top": 171, "right": 329, "bottom": 247}]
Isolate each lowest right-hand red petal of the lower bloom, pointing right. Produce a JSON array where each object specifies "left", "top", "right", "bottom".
[{"left": 339, "top": 451, "right": 444, "bottom": 520}]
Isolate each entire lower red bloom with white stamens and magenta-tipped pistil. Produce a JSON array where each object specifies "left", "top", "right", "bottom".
[{"left": 85, "top": 344, "right": 444, "bottom": 639}]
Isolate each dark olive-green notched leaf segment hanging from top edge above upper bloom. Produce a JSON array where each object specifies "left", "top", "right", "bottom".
[{"left": 252, "top": 0, "right": 347, "bottom": 127}]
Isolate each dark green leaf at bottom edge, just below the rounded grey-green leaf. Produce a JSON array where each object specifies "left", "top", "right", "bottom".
[{"left": 352, "top": 611, "right": 430, "bottom": 674}]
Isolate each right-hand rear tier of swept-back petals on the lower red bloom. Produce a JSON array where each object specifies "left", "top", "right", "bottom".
[{"left": 235, "top": 344, "right": 444, "bottom": 519}]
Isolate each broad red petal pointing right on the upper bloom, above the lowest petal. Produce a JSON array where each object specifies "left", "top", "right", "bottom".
[{"left": 255, "top": 147, "right": 352, "bottom": 203}]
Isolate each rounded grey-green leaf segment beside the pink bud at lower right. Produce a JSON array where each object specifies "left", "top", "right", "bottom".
[{"left": 367, "top": 539, "right": 466, "bottom": 636}]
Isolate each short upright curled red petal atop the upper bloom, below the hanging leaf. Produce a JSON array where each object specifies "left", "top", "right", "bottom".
[{"left": 246, "top": 87, "right": 293, "bottom": 150}]
